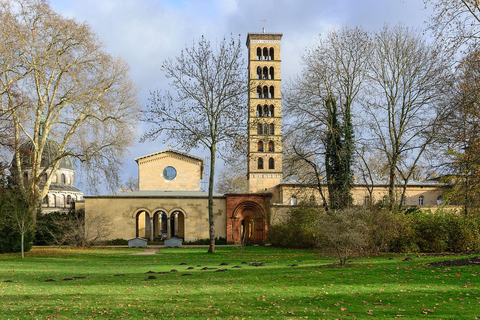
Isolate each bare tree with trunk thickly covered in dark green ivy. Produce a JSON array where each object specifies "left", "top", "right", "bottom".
[{"left": 286, "top": 28, "right": 371, "bottom": 208}]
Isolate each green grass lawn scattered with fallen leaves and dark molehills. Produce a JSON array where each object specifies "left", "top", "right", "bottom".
[{"left": 0, "top": 247, "right": 480, "bottom": 319}]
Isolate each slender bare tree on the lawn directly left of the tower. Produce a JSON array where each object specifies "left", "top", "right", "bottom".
[{"left": 142, "top": 37, "right": 248, "bottom": 253}]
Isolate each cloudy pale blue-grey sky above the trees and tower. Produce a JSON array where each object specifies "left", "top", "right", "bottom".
[{"left": 51, "top": 0, "right": 436, "bottom": 193}]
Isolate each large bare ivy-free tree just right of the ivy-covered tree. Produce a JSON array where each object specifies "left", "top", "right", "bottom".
[{"left": 365, "top": 25, "right": 451, "bottom": 209}]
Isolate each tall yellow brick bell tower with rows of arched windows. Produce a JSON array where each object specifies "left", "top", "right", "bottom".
[{"left": 247, "top": 32, "right": 282, "bottom": 192}]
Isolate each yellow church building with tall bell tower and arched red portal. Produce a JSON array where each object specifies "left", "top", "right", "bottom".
[{"left": 85, "top": 33, "right": 445, "bottom": 244}]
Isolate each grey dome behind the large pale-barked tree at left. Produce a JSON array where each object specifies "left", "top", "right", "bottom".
[{"left": 16, "top": 139, "right": 73, "bottom": 170}]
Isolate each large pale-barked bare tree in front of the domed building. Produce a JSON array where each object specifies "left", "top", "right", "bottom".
[{"left": 0, "top": 0, "right": 139, "bottom": 216}]
